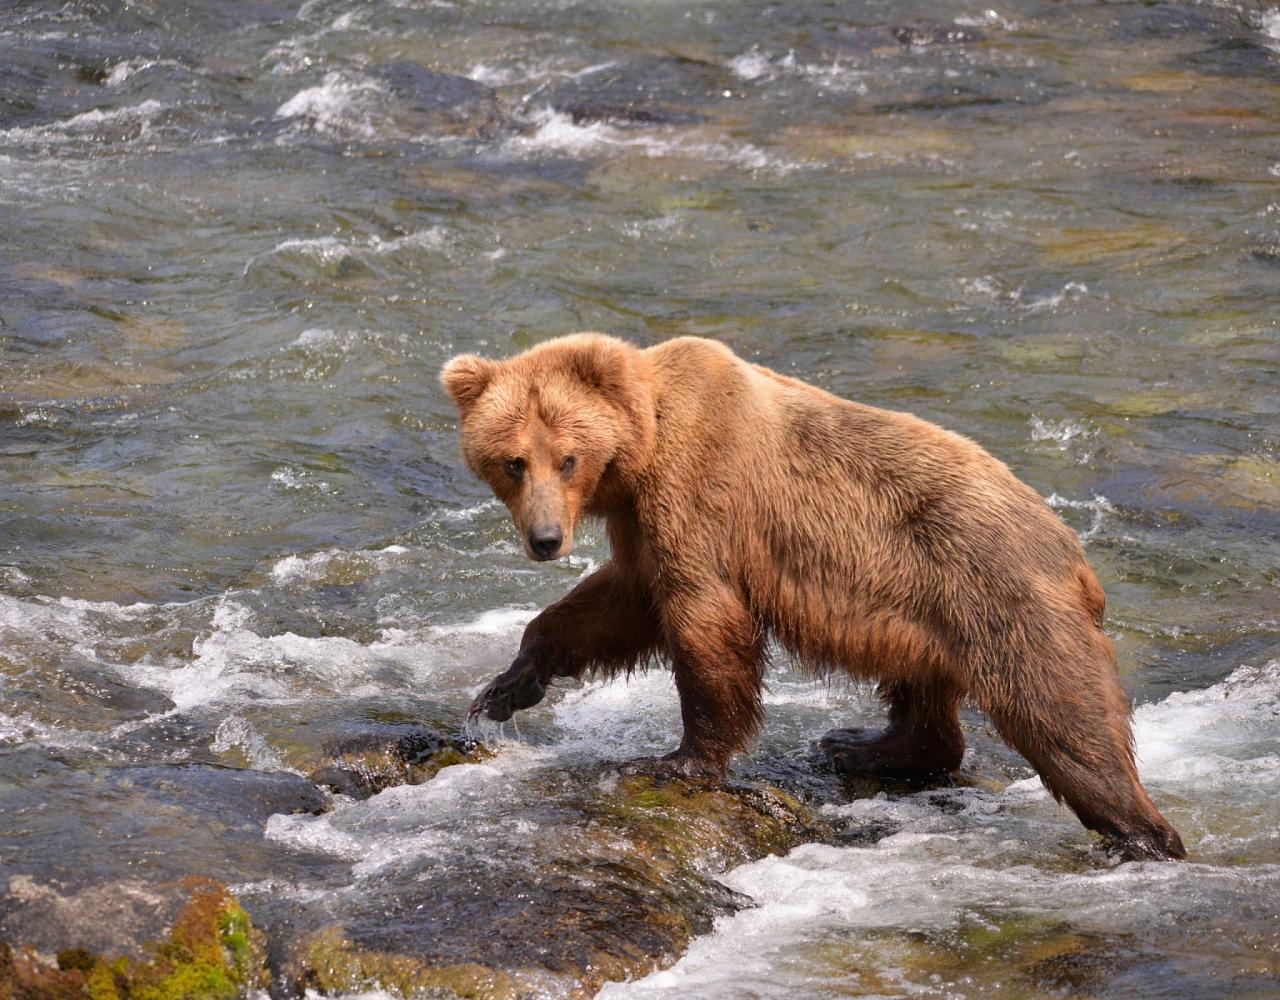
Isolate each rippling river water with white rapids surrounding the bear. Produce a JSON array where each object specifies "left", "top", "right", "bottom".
[{"left": 0, "top": 0, "right": 1280, "bottom": 997}]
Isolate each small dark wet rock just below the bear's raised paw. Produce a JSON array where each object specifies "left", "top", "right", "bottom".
[{"left": 308, "top": 729, "right": 490, "bottom": 799}]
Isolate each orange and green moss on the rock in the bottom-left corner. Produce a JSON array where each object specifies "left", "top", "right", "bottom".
[{"left": 0, "top": 876, "right": 268, "bottom": 1000}]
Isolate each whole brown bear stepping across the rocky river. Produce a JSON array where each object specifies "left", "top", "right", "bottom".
[{"left": 442, "top": 333, "right": 1185, "bottom": 859}]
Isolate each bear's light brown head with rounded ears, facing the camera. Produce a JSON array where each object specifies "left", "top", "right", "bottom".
[{"left": 440, "top": 333, "right": 654, "bottom": 561}]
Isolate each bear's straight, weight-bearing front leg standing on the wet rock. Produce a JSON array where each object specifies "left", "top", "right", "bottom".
[{"left": 628, "top": 590, "right": 764, "bottom": 778}]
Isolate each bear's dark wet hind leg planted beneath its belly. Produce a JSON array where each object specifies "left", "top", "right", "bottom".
[{"left": 818, "top": 681, "right": 964, "bottom": 781}]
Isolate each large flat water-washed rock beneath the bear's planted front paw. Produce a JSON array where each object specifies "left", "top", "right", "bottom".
[{"left": 272, "top": 773, "right": 827, "bottom": 997}]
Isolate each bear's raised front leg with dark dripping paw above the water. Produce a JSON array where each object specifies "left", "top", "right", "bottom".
[{"left": 467, "top": 562, "right": 659, "bottom": 722}]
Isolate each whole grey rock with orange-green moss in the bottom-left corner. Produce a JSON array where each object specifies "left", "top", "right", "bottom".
[{"left": 0, "top": 876, "right": 266, "bottom": 1000}]
